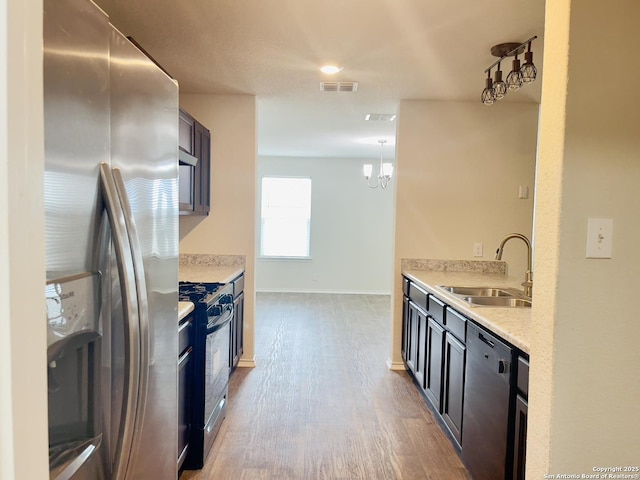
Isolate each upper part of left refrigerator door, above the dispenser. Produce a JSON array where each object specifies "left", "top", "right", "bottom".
[{"left": 43, "top": 0, "right": 110, "bottom": 280}]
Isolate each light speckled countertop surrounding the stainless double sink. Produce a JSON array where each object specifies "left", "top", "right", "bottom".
[{"left": 402, "top": 270, "right": 531, "bottom": 353}]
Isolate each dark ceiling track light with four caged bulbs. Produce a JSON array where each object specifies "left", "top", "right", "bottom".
[{"left": 480, "top": 36, "right": 538, "bottom": 105}]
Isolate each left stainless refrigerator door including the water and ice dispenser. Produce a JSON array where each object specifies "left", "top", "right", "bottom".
[{"left": 43, "top": 0, "right": 110, "bottom": 480}]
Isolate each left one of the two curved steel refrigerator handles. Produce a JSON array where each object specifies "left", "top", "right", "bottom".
[{"left": 100, "top": 163, "right": 140, "bottom": 480}]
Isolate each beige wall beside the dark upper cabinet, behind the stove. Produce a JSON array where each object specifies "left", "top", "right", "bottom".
[{"left": 180, "top": 94, "right": 257, "bottom": 362}]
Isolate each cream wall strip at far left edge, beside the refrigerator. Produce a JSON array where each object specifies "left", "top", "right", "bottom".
[{"left": 0, "top": 0, "right": 49, "bottom": 480}]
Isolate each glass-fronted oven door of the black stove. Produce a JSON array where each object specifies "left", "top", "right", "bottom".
[{"left": 204, "top": 311, "right": 233, "bottom": 457}]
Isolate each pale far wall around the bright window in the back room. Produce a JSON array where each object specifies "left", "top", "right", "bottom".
[{"left": 256, "top": 154, "right": 395, "bottom": 294}]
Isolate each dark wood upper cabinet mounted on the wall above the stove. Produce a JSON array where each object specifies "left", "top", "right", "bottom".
[{"left": 178, "top": 109, "right": 211, "bottom": 215}]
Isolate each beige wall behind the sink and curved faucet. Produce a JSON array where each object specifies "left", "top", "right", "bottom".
[{"left": 391, "top": 100, "right": 538, "bottom": 366}]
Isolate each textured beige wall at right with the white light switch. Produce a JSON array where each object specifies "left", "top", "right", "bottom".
[{"left": 527, "top": 0, "right": 640, "bottom": 479}]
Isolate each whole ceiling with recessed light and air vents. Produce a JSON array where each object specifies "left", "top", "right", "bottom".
[{"left": 96, "top": 0, "right": 544, "bottom": 158}]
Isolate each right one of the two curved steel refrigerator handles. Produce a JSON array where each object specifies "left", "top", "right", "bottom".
[{"left": 112, "top": 167, "right": 150, "bottom": 466}]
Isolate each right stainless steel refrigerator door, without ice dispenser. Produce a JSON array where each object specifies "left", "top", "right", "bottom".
[{"left": 110, "top": 29, "right": 178, "bottom": 480}]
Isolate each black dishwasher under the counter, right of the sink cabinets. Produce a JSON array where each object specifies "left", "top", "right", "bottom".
[{"left": 462, "top": 323, "right": 512, "bottom": 480}]
